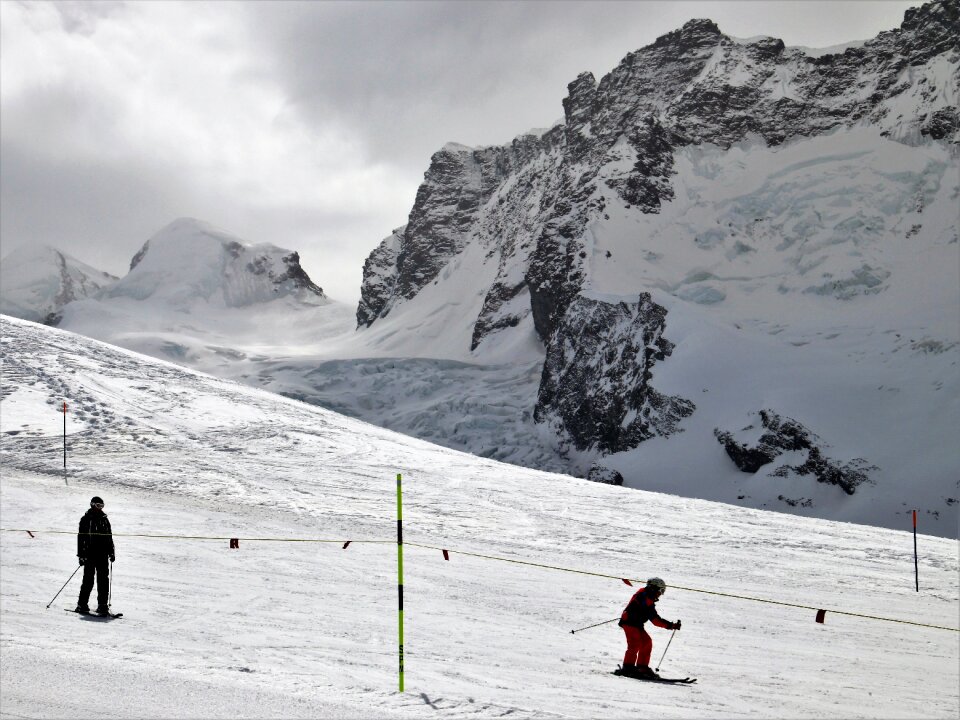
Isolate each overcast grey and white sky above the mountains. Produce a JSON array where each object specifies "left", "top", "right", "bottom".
[{"left": 0, "top": 0, "right": 920, "bottom": 303}]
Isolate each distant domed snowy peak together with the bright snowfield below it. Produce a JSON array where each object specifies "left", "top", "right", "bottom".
[{"left": 48, "top": 218, "right": 352, "bottom": 372}]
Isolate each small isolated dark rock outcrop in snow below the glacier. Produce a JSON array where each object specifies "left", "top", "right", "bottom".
[{"left": 714, "top": 410, "right": 877, "bottom": 501}]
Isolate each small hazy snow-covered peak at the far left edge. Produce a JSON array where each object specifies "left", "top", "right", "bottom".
[{"left": 0, "top": 245, "right": 116, "bottom": 322}]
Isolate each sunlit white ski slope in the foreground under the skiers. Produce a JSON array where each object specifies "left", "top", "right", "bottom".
[{"left": 0, "top": 317, "right": 960, "bottom": 718}]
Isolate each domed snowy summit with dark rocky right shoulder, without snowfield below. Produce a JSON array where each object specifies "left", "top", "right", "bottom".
[{"left": 109, "top": 218, "right": 326, "bottom": 309}]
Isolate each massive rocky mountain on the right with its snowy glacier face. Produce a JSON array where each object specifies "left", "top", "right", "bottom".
[{"left": 346, "top": 0, "right": 960, "bottom": 523}]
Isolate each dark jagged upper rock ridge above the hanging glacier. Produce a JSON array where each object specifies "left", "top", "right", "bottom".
[{"left": 358, "top": 0, "right": 960, "bottom": 348}]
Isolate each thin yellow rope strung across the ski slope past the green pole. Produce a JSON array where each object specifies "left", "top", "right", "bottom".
[{"left": 0, "top": 528, "right": 960, "bottom": 632}]
